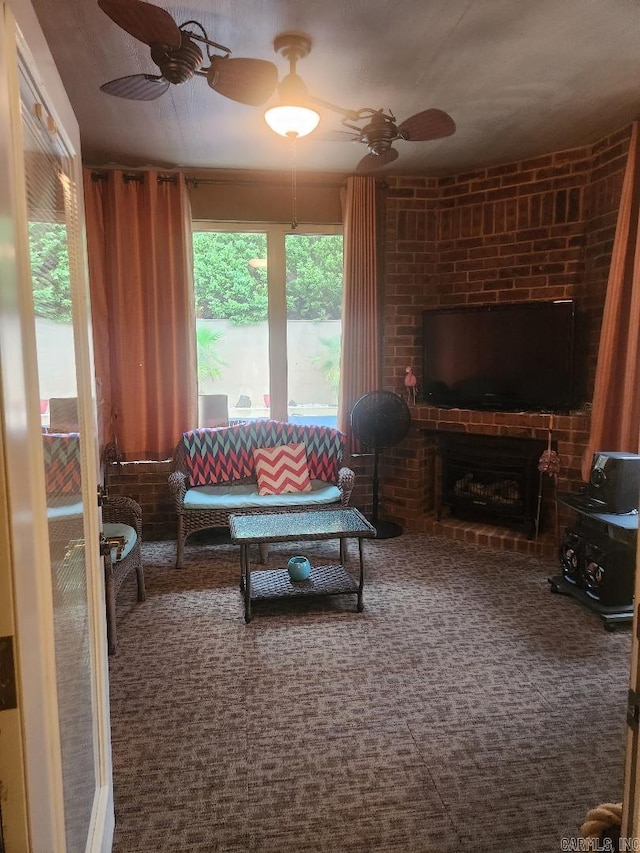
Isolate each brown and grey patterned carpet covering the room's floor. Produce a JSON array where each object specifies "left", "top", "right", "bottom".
[{"left": 110, "top": 534, "right": 631, "bottom": 853}]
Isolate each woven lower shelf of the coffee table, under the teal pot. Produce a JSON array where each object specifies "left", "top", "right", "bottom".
[{"left": 248, "top": 565, "right": 363, "bottom": 612}]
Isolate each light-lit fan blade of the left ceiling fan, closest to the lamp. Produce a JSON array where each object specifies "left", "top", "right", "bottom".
[{"left": 207, "top": 56, "right": 278, "bottom": 107}]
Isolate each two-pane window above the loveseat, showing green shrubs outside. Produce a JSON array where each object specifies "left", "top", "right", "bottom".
[{"left": 193, "top": 223, "right": 343, "bottom": 426}]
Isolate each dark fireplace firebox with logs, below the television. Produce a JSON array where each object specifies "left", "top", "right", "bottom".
[{"left": 438, "top": 434, "right": 547, "bottom": 538}]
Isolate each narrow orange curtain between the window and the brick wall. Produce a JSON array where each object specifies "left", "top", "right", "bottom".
[{"left": 338, "top": 177, "right": 380, "bottom": 433}]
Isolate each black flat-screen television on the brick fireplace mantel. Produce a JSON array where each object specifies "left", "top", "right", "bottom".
[{"left": 422, "top": 300, "right": 575, "bottom": 412}]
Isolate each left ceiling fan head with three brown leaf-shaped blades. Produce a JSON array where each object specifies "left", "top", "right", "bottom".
[{"left": 98, "top": 0, "right": 278, "bottom": 106}]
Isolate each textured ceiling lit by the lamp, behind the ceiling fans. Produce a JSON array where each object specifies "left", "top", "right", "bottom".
[{"left": 33, "top": 0, "right": 640, "bottom": 175}]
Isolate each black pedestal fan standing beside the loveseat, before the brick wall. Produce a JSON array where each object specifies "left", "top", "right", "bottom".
[{"left": 351, "top": 391, "right": 411, "bottom": 539}]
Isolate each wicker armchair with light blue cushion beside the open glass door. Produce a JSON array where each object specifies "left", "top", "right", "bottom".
[{"left": 102, "top": 496, "right": 146, "bottom": 655}]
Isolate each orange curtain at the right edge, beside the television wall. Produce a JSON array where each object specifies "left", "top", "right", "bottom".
[{"left": 582, "top": 122, "right": 640, "bottom": 481}]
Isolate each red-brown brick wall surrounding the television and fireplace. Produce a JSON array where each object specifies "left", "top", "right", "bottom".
[{"left": 381, "top": 128, "right": 630, "bottom": 550}]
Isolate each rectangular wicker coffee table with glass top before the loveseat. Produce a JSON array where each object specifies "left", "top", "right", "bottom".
[{"left": 229, "top": 507, "right": 376, "bottom": 622}]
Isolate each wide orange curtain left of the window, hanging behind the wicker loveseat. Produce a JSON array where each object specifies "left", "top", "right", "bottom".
[{"left": 84, "top": 169, "right": 197, "bottom": 460}]
